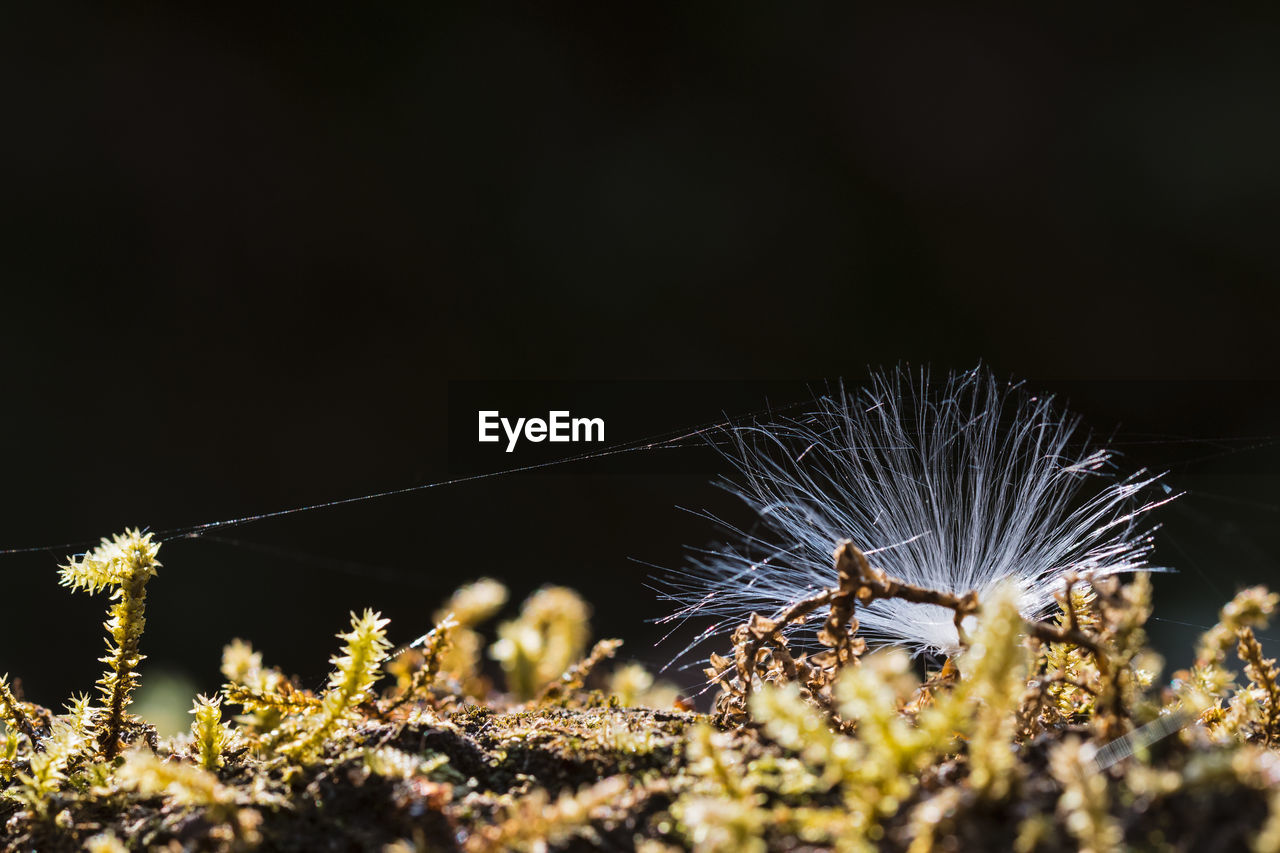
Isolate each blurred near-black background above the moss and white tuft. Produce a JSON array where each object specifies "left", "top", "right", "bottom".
[{"left": 0, "top": 4, "right": 1280, "bottom": 703}]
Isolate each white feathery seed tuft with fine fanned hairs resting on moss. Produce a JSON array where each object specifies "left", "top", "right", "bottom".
[{"left": 662, "top": 368, "right": 1176, "bottom": 653}]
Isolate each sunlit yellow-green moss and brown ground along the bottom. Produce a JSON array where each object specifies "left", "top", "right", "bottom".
[{"left": 0, "top": 532, "right": 1280, "bottom": 853}]
